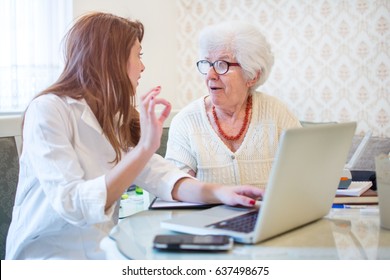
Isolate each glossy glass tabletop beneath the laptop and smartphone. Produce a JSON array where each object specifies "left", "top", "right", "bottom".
[{"left": 101, "top": 207, "right": 390, "bottom": 260}]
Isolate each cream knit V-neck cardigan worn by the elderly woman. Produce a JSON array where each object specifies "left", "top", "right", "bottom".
[{"left": 165, "top": 92, "right": 301, "bottom": 188}]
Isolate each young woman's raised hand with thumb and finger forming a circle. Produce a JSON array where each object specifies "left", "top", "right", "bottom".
[{"left": 138, "top": 86, "right": 171, "bottom": 153}]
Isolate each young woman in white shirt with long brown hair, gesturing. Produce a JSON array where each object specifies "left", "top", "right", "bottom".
[{"left": 6, "top": 13, "right": 262, "bottom": 259}]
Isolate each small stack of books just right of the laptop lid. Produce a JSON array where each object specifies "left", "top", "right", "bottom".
[{"left": 333, "top": 181, "right": 378, "bottom": 204}]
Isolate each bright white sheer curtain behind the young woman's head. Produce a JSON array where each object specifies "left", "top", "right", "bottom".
[{"left": 0, "top": 0, "right": 73, "bottom": 113}]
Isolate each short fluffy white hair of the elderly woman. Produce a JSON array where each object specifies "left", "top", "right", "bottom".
[{"left": 199, "top": 21, "right": 274, "bottom": 91}]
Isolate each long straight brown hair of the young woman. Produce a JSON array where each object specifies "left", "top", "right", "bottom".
[{"left": 34, "top": 13, "right": 144, "bottom": 163}]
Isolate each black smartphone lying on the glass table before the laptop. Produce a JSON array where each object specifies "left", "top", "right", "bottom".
[{"left": 153, "top": 234, "right": 234, "bottom": 251}]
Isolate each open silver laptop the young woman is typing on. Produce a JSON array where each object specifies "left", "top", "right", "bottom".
[{"left": 161, "top": 122, "right": 356, "bottom": 244}]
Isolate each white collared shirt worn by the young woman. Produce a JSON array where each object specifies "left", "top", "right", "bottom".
[{"left": 6, "top": 94, "right": 188, "bottom": 259}]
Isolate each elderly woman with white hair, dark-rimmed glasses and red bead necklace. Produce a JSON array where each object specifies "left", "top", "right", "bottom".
[{"left": 165, "top": 22, "right": 300, "bottom": 188}]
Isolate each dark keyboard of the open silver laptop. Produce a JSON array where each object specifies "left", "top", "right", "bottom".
[{"left": 207, "top": 211, "right": 259, "bottom": 233}]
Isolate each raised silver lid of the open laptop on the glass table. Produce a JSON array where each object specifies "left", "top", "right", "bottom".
[{"left": 254, "top": 122, "right": 356, "bottom": 242}]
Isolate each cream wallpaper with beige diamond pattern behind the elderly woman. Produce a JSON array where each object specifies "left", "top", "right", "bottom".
[{"left": 174, "top": 0, "right": 390, "bottom": 137}]
